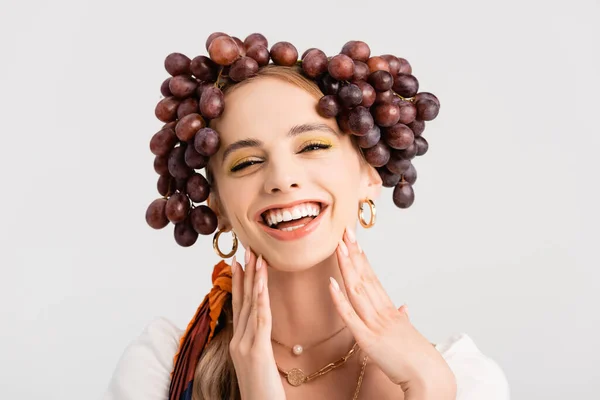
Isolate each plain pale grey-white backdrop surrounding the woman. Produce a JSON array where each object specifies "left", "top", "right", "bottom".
[{"left": 0, "top": 0, "right": 600, "bottom": 400}]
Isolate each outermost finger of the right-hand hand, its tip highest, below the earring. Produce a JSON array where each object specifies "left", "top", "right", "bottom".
[{"left": 344, "top": 227, "right": 396, "bottom": 310}]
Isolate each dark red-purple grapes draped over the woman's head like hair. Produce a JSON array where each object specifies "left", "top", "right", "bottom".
[{"left": 146, "top": 32, "right": 440, "bottom": 247}]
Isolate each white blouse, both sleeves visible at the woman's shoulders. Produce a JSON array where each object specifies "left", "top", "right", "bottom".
[{"left": 102, "top": 318, "right": 510, "bottom": 400}]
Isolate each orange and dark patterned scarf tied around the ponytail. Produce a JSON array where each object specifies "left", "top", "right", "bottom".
[{"left": 169, "top": 261, "right": 232, "bottom": 400}]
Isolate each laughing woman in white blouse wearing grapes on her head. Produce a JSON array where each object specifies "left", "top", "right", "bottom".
[{"left": 105, "top": 33, "right": 509, "bottom": 400}]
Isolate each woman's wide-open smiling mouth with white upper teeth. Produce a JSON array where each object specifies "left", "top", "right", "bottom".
[{"left": 261, "top": 201, "right": 327, "bottom": 232}]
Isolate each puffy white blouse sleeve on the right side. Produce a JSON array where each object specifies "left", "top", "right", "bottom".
[{"left": 436, "top": 333, "right": 510, "bottom": 400}]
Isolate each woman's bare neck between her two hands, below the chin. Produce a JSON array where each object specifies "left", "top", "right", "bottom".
[{"left": 269, "top": 254, "right": 354, "bottom": 354}]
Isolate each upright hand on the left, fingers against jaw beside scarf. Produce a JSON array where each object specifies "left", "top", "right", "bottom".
[{"left": 229, "top": 248, "right": 285, "bottom": 400}]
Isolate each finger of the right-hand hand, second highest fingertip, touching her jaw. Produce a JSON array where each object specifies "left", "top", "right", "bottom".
[{"left": 336, "top": 240, "right": 377, "bottom": 322}]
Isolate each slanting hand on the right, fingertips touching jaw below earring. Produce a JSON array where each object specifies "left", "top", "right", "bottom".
[{"left": 329, "top": 229, "right": 456, "bottom": 400}]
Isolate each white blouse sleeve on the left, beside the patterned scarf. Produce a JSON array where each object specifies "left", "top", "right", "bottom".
[{"left": 102, "top": 318, "right": 183, "bottom": 400}]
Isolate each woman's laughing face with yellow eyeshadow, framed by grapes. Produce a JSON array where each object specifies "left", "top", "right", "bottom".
[{"left": 210, "top": 77, "right": 381, "bottom": 270}]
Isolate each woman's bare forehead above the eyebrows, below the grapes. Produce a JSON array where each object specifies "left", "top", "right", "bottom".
[{"left": 216, "top": 77, "right": 324, "bottom": 143}]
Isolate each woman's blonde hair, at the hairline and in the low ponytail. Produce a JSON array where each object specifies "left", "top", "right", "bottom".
[{"left": 192, "top": 65, "right": 323, "bottom": 400}]
